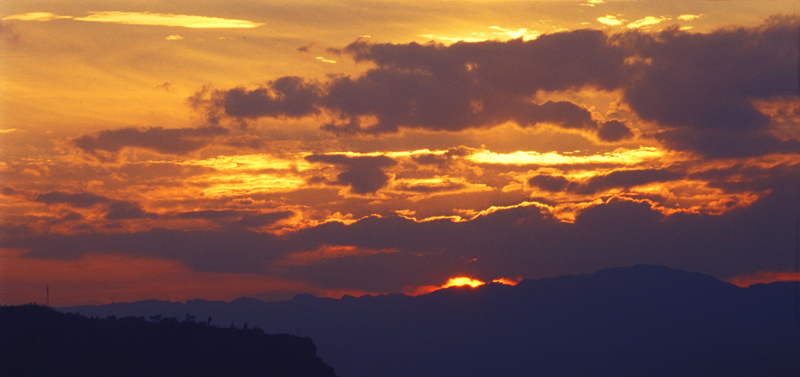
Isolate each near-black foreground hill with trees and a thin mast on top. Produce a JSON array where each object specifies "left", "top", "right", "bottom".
[{"left": 0, "top": 305, "right": 335, "bottom": 377}]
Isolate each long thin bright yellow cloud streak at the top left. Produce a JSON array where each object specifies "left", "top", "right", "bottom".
[{"left": 3, "top": 11, "right": 263, "bottom": 29}]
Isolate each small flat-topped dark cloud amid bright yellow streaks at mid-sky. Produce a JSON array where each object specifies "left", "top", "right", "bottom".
[{"left": 306, "top": 154, "right": 397, "bottom": 194}]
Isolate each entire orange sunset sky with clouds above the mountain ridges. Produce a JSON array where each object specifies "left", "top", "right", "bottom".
[{"left": 0, "top": 0, "right": 800, "bottom": 306}]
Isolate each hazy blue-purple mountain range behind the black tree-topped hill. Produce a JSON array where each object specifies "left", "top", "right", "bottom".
[{"left": 64, "top": 266, "right": 800, "bottom": 377}]
